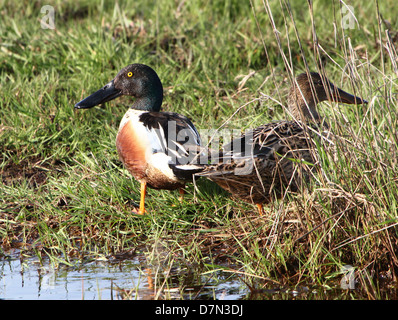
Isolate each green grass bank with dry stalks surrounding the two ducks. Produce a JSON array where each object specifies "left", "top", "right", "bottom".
[{"left": 0, "top": 0, "right": 398, "bottom": 299}]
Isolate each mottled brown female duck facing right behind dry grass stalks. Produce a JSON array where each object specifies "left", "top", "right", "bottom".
[{"left": 197, "top": 73, "right": 366, "bottom": 214}]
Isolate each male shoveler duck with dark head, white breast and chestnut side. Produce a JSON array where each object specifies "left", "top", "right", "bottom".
[{"left": 75, "top": 64, "right": 202, "bottom": 214}]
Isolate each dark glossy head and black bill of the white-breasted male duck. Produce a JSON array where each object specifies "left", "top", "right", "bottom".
[{"left": 75, "top": 64, "right": 163, "bottom": 111}]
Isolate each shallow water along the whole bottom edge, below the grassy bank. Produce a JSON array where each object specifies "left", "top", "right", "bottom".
[{"left": 0, "top": 251, "right": 392, "bottom": 300}]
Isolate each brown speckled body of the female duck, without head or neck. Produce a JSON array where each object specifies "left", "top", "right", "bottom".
[{"left": 199, "top": 121, "right": 316, "bottom": 204}]
